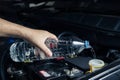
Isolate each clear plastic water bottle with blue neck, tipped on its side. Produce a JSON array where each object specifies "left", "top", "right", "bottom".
[{"left": 10, "top": 39, "right": 91, "bottom": 62}]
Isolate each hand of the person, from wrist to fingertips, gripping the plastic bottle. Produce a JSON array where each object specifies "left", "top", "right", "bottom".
[{"left": 25, "top": 29, "right": 58, "bottom": 56}]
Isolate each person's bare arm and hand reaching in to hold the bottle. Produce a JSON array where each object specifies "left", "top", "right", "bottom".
[{"left": 0, "top": 18, "right": 57, "bottom": 56}]
